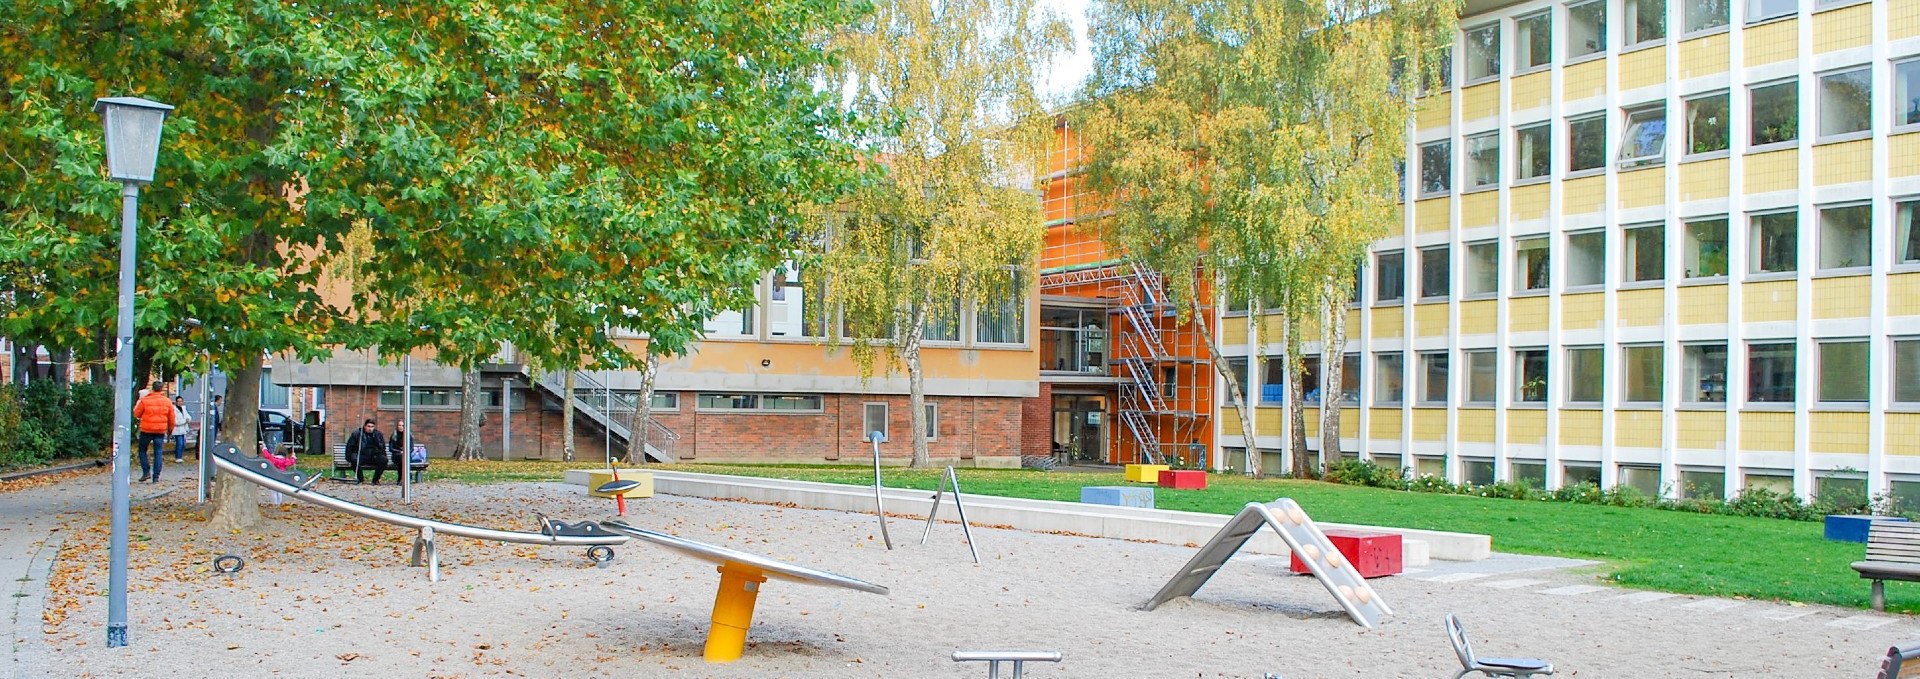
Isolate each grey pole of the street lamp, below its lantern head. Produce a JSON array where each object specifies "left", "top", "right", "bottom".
[{"left": 108, "top": 182, "right": 140, "bottom": 648}]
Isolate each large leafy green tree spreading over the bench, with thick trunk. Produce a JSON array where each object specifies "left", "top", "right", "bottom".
[{"left": 0, "top": 0, "right": 862, "bottom": 527}]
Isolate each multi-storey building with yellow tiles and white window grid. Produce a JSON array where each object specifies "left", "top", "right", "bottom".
[{"left": 1217, "top": 0, "right": 1920, "bottom": 499}]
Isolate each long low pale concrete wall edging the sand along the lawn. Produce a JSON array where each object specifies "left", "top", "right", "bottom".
[{"left": 591, "top": 472, "right": 1494, "bottom": 568}]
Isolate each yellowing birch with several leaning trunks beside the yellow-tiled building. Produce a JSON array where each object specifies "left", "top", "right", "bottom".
[{"left": 1079, "top": 0, "right": 1459, "bottom": 476}]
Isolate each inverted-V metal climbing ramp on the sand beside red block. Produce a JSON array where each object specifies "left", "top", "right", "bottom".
[{"left": 1146, "top": 497, "right": 1394, "bottom": 629}]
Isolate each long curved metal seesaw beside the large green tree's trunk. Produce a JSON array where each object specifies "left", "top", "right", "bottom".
[{"left": 213, "top": 443, "right": 626, "bottom": 581}]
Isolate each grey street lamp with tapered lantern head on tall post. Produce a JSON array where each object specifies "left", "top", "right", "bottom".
[{"left": 94, "top": 96, "right": 173, "bottom": 648}]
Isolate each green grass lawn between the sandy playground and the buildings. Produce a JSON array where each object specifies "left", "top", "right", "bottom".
[{"left": 416, "top": 460, "right": 1889, "bottom": 612}]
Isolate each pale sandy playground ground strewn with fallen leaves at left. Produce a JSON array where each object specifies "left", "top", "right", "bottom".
[{"left": 25, "top": 478, "right": 1920, "bottom": 679}]
